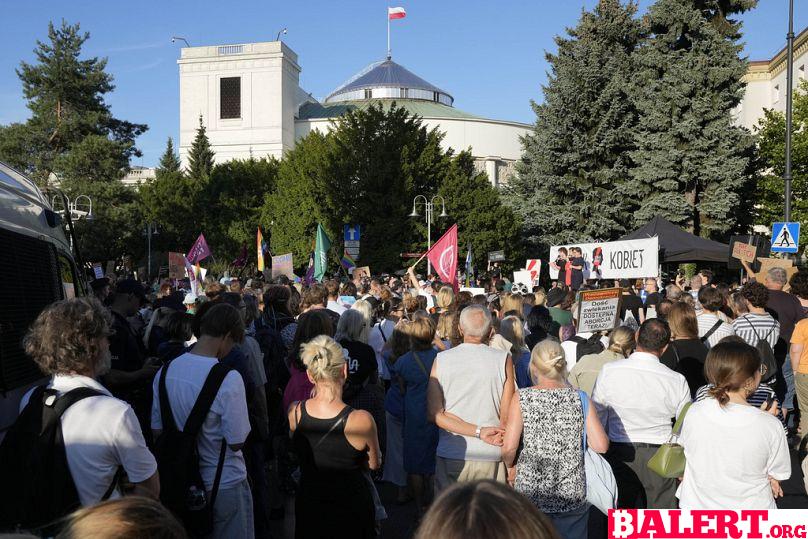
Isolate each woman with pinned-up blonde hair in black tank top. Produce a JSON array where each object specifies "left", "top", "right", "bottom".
[{"left": 289, "top": 336, "right": 381, "bottom": 538}]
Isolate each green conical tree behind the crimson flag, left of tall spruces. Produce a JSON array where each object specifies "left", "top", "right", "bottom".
[{"left": 435, "top": 151, "right": 522, "bottom": 267}]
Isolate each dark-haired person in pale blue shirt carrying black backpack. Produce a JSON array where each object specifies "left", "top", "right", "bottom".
[{"left": 151, "top": 303, "right": 254, "bottom": 539}]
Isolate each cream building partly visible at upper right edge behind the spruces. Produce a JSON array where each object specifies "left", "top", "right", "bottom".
[{"left": 735, "top": 28, "right": 808, "bottom": 131}]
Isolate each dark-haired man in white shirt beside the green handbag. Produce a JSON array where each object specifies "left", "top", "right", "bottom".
[{"left": 592, "top": 319, "right": 690, "bottom": 509}]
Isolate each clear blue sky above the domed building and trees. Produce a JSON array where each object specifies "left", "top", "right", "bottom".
[{"left": 0, "top": 0, "right": 808, "bottom": 166}]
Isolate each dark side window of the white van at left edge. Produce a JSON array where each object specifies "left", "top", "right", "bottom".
[{"left": 0, "top": 228, "right": 64, "bottom": 392}]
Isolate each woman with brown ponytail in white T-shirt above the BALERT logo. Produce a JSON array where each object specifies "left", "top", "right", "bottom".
[{"left": 677, "top": 342, "right": 791, "bottom": 511}]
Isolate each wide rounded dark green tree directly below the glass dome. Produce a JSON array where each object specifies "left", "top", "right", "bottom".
[{"left": 264, "top": 103, "right": 452, "bottom": 272}]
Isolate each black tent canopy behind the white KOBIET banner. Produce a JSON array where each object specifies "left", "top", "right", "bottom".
[{"left": 620, "top": 216, "right": 729, "bottom": 263}]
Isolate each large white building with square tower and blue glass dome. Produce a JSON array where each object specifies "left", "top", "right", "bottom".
[{"left": 177, "top": 41, "right": 531, "bottom": 185}]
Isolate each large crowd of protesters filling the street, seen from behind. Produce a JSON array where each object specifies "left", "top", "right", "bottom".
[{"left": 4, "top": 264, "right": 808, "bottom": 538}]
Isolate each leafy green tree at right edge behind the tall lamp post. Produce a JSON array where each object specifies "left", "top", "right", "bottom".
[{"left": 754, "top": 81, "right": 808, "bottom": 224}]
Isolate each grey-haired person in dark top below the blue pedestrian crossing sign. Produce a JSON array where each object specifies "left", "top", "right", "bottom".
[{"left": 763, "top": 268, "right": 805, "bottom": 414}]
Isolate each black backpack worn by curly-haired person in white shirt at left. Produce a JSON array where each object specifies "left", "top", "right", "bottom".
[{"left": 0, "top": 386, "right": 120, "bottom": 535}]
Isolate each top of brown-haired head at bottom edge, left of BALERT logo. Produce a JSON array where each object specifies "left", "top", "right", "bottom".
[{"left": 415, "top": 481, "right": 559, "bottom": 539}]
